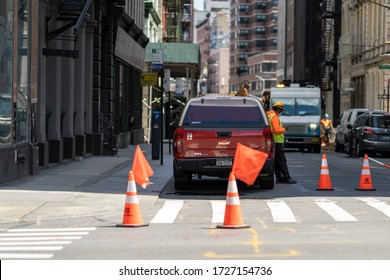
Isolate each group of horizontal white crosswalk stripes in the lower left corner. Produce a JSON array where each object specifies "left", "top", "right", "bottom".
[{"left": 0, "top": 227, "right": 96, "bottom": 259}]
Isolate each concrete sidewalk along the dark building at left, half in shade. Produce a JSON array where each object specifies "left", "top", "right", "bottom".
[{"left": 0, "top": 144, "right": 173, "bottom": 227}]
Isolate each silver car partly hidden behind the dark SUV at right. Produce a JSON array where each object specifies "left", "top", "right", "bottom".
[{"left": 334, "top": 108, "right": 384, "bottom": 152}]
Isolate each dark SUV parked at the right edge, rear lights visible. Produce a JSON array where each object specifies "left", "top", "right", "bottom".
[{"left": 346, "top": 111, "right": 390, "bottom": 156}]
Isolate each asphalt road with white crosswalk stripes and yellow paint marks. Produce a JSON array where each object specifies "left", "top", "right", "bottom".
[{"left": 0, "top": 151, "right": 390, "bottom": 260}]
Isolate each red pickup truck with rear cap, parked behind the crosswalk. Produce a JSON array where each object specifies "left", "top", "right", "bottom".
[{"left": 172, "top": 96, "right": 274, "bottom": 190}]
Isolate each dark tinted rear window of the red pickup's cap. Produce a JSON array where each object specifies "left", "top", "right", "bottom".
[{"left": 183, "top": 104, "right": 264, "bottom": 126}]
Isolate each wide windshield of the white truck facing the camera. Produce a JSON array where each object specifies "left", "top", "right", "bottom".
[{"left": 273, "top": 98, "right": 320, "bottom": 116}]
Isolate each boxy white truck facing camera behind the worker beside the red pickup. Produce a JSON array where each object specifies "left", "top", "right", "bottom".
[{"left": 270, "top": 83, "right": 321, "bottom": 153}]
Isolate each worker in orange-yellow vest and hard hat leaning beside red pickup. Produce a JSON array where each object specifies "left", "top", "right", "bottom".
[{"left": 267, "top": 101, "right": 297, "bottom": 184}]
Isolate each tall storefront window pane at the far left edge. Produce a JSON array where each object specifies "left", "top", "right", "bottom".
[{"left": 0, "top": 0, "right": 13, "bottom": 146}]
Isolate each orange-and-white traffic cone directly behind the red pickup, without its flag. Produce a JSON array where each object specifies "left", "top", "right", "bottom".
[{"left": 217, "top": 172, "right": 250, "bottom": 229}]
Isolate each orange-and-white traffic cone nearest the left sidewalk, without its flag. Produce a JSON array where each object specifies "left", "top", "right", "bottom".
[{"left": 116, "top": 171, "right": 148, "bottom": 227}]
